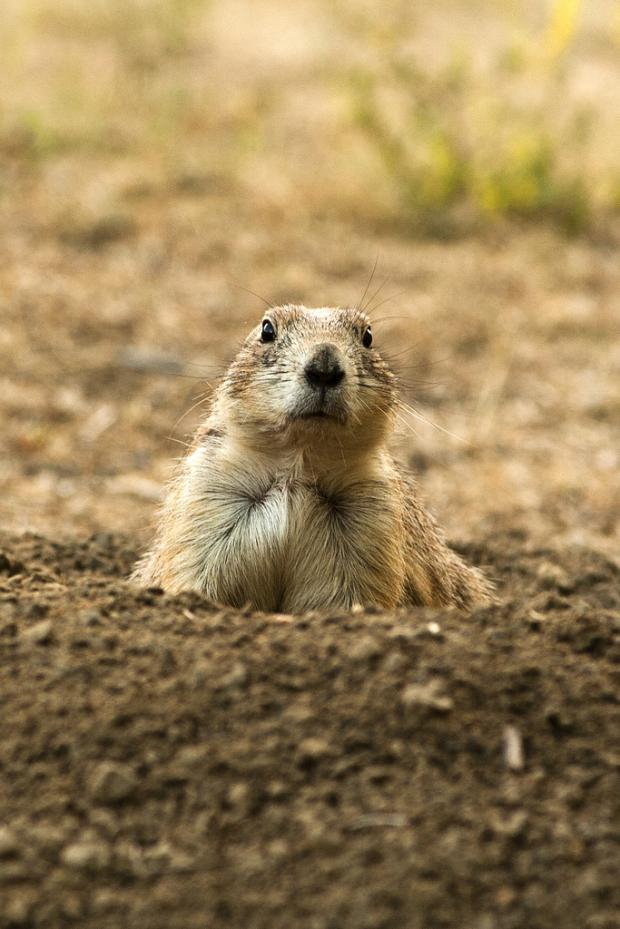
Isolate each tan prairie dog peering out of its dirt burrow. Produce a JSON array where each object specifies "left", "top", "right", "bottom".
[{"left": 132, "top": 306, "right": 491, "bottom": 613}]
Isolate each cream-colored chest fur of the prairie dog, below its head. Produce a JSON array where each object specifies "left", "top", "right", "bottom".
[{"left": 159, "top": 447, "right": 405, "bottom": 612}]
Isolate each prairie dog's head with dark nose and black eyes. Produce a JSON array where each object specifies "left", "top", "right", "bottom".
[{"left": 220, "top": 306, "right": 396, "bottom": 448}]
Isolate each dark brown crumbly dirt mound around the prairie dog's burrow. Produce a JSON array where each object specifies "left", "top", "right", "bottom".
[{"left": 0, "top": 534, "right": 620, "bottom": 929}]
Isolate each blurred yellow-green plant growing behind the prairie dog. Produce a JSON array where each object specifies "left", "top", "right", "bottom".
[{"left": 349, "top": 0, "right": 591, "bottom": 232}]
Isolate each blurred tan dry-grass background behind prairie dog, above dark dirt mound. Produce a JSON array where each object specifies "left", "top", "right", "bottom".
[{"left": 0, "top": 0, "right": 620, "bottom": 557}]
